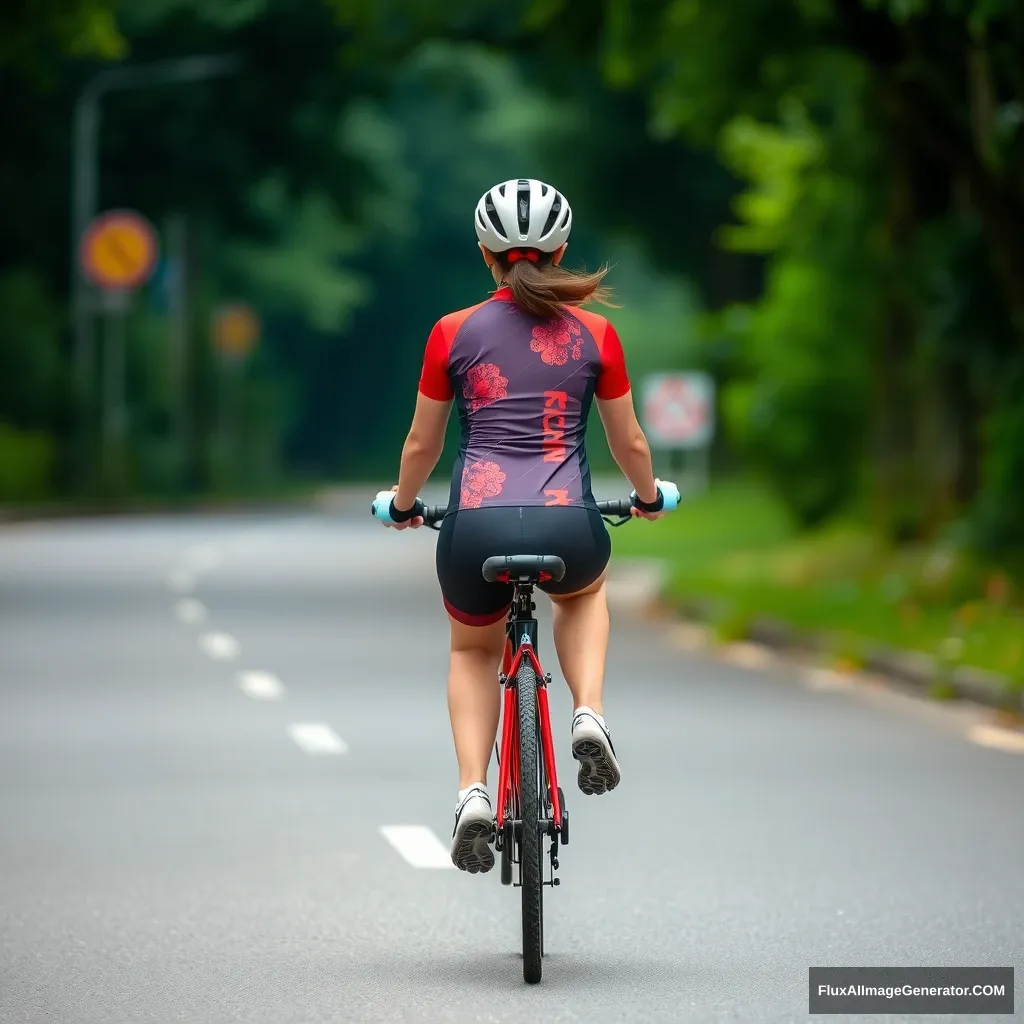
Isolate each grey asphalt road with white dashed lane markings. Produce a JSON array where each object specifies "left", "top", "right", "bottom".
[{"left": 0, "top": 503, "right": 1024, "bottom": 1024}]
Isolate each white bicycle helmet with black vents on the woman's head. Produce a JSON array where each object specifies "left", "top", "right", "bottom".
[{"left": 473, "top": 178, "right": 572, "bottom": 253}]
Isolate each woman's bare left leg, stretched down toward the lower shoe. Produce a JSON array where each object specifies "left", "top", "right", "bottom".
[{"left": 449, "top": 615, "right": 505, "bottom": 790}]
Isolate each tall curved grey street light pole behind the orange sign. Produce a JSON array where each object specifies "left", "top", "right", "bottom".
[{"left": 71, "top": 55, "right": 239, "bottom": 493}]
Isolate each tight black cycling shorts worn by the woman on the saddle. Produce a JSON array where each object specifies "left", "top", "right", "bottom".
[{"left": 436, "top": 505, "right": 611, "bottom": 626}]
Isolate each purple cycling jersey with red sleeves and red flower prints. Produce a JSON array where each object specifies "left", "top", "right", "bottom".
[{"left": 419, "top": 288, "right": 630, "bottom": 511}]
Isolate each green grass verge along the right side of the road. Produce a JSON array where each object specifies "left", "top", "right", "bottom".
[{"left": 612, "top": 482, "right": 1024, "bottom": 686}]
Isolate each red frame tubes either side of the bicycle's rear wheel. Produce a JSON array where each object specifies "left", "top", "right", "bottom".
[{"left": 497, "top": 618, "right": 562, "bottom": 830}]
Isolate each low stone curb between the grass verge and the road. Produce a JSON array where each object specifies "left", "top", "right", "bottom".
[{"left": 647, "top": 565, "right": 1024, "bottom": 716}]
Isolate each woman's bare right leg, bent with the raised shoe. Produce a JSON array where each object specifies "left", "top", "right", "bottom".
[{"left": 549, "top": 572, "right": 609, "bottom": 715}]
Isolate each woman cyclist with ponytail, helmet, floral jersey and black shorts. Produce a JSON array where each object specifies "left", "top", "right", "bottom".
[{"left": 374, "top": 180, "right": 664, "bottom": 872}]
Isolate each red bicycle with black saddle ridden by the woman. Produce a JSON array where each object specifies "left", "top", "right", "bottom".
[{"left": 378, "top": 491, "right": 679, "bottom": 984}]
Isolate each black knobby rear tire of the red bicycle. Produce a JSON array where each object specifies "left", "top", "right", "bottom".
[{"left": 515, "top": 658, "right": 544, "bottom": 985}]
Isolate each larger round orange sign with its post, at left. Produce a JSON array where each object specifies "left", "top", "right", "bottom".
[{"left": 79, "top": 210, "right": 158, "bottom": 482}]
